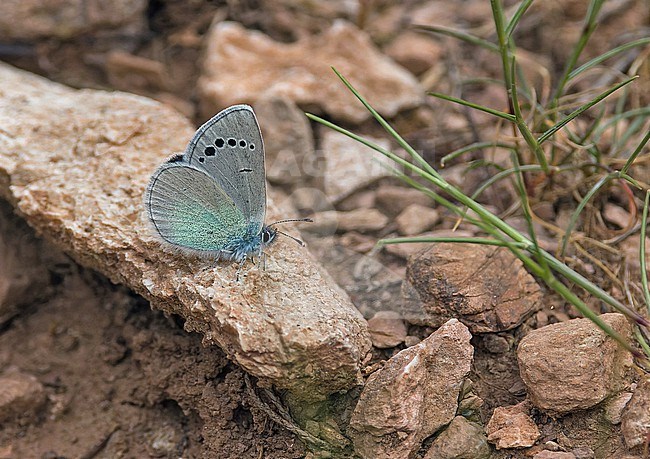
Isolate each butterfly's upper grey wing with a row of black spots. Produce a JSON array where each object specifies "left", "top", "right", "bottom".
[{"left": 183, "top": 105, "right": 266, "bottom": 231}]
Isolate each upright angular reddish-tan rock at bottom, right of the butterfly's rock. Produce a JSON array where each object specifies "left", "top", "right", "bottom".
[{"left": 349, "top": 320, "right": 473, "bottom": 459}]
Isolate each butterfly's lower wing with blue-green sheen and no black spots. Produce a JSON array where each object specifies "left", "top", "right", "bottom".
[{"left": 144, "top": 157, "right": 248, "bottom": 255}]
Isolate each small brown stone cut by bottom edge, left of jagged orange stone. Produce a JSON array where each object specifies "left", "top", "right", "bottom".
[{"left": 424, "top": 416, "right": 491, "bottom": 459}]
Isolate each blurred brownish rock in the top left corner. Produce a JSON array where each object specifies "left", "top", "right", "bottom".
[{"left": 0, "top": 0, "right": 147, "bottom": 40}]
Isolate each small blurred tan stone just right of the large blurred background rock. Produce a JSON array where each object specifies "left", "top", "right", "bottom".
[{"left": 384, "top": 31, "right": 443, "bottom": 75}]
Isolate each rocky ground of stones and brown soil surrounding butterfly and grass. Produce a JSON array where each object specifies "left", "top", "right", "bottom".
[{"left": 0, "top": 0, "right": 650, "bottom": 459}]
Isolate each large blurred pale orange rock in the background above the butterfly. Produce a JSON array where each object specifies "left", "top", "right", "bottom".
[{"left": 198, "top": 21, "right": 424, "bottom": 122}]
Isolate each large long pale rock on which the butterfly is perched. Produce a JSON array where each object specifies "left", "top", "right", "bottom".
[{"left": 0, "top": 65, "right": 370, "bottom": 398}]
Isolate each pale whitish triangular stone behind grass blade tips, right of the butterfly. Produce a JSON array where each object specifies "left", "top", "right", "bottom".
[{"left": 322, "top": 130, "right": 390, "bottom": 203}]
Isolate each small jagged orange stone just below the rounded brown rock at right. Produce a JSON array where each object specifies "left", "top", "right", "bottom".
[{"left": 486, "top": 401, "right": 540, "bottom": 449}]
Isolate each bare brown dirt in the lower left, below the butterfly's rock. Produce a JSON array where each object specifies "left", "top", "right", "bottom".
[{"left": 0, "top": 211, "right": 304, "bottom": 459}]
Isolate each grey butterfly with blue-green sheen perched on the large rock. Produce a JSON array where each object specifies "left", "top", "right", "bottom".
[{"left": 144, "top": 105, "right": 312, "bottom": 267}]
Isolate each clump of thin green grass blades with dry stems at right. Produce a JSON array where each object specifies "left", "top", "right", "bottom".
[{"left": 308, "top": 0, "right": 650, "bottom": 368}]
